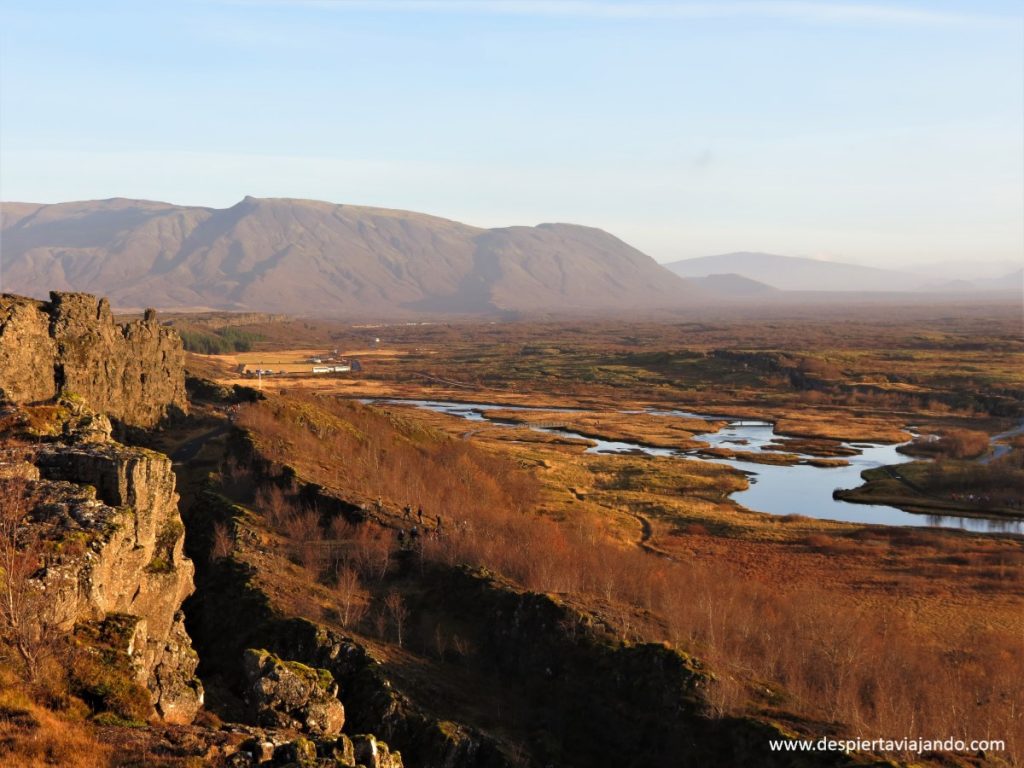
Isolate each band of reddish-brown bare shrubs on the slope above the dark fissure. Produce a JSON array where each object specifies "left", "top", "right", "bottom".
[{"left": 240, "top": 396, "right": 1024, "bottom": 755}]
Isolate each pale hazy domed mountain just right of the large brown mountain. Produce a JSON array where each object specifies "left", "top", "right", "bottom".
[{"left": 665, "top": 252, "right": 922, "bottom": 291}]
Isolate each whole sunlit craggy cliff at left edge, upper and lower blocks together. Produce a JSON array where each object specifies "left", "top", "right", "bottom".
[{"left": 0, "top": 286, "right": 203, "bottom": 723}]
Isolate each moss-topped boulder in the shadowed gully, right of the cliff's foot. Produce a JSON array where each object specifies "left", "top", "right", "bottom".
[{"left": 243, "top": 648, "right": 345, "bottom": 736}]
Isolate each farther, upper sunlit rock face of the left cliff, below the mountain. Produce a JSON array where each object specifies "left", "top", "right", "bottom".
[{"left": 0, "top": 293, "right": 186, "bottom": 427}]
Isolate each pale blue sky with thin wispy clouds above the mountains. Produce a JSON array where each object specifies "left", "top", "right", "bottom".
[{"left": 0, "top": 0, "right": 1024, "bottom": 267}]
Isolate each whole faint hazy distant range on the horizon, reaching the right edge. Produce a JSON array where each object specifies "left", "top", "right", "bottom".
[{"left": 665, "top": 252, "right": 1024, "bottom": 293}]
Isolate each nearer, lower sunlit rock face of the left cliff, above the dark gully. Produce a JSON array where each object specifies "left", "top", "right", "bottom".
[{"left": 32, "top": 437, "right": 203, "bottom": 723}]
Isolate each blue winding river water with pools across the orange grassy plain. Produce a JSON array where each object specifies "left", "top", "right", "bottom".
[{"left": 364, "top": 399, "right": 1024, "bottom": 534}]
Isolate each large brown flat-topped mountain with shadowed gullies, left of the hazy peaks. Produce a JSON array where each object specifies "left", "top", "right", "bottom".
[{"left": 0, "top": 198, "right": 701, "bottom": 315}]
